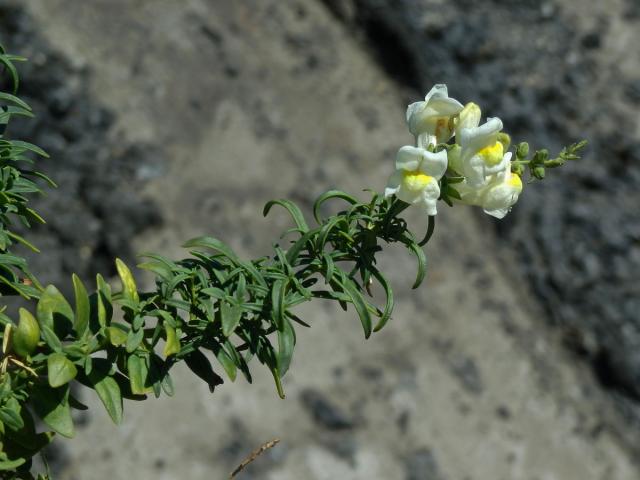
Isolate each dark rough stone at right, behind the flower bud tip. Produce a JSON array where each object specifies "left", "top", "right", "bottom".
[{"left": 324, "top": 0, "right": 640, "bottom": 421}]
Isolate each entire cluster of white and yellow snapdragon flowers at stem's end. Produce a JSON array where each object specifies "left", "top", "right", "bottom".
[{"left": 385, "top": 85, "right": 522, "bottom": 218}]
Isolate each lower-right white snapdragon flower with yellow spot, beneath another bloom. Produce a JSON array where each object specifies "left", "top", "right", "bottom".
[{"left": 454, "top": 152, "right": 522, "bottom": 218}]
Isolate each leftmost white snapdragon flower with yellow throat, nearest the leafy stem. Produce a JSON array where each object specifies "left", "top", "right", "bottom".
[{"left": 384, "top": 146, "right": 447, "bottom": 215}]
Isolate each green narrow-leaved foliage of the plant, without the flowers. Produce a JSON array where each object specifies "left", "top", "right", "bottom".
[{"left": 0, "top": 42, "right": 432, "bottom": 478}]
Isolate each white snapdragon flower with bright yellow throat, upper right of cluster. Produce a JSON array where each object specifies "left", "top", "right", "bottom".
[{"left": 452, "top": 118, "right": 511, "bottom": 188}]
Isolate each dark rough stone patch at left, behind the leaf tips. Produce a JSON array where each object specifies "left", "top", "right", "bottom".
[{"left": 0, "top": 2, "right": 161, "bottom": 293}]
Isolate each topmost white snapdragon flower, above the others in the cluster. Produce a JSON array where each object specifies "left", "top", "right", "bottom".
[{"left": 407, "top": 84, "right": 463, "bottom": 148}]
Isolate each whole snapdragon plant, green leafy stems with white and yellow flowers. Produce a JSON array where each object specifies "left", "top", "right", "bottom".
[{"left": 0, "top": 47, "right": 584, "bottom": 478}]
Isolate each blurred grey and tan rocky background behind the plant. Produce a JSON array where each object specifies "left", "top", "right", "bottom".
[{"left": 0, "top": 0, "right": 640, "bottom": 480}]
